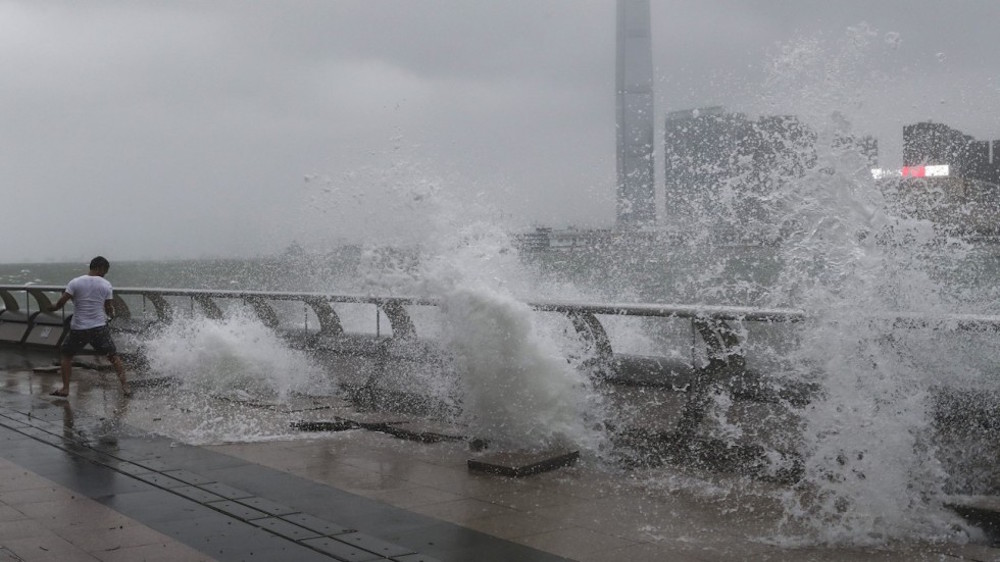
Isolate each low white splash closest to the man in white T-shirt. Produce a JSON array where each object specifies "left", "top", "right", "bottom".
[{"left": 132, "top": 307, "right": 336, "bottom": 444}]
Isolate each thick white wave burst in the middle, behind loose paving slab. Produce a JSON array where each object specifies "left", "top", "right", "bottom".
[{"left": 421, "top": 222, "right": 603, "bottom": 452}]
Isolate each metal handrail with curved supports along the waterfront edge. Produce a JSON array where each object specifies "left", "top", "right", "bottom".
[{"left": 0, "top": 285, "right": 1000, "bottom": 447}]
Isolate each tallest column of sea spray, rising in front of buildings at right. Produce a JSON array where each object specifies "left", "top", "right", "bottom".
[{"left": 640, "top": 24, "right": 992, "bottom": 544}]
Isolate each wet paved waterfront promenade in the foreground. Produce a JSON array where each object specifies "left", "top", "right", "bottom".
[{"left": 0, "top": 350, "right": 1000, "bottom": 562}]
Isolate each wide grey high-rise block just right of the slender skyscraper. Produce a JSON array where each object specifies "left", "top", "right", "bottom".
[{"left": 663, "top": 107, "right": 878, "bottom": 241}]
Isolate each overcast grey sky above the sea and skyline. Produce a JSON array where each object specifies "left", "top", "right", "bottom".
[{"left": 0, "top": 0, "right": 1000, "bottom": 262}]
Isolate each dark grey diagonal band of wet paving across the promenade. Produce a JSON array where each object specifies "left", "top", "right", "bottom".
[{"left": 0, "top": 382, "right": 566, "bottom": 562}]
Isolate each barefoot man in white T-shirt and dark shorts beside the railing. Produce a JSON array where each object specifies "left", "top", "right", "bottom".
[{"left": 51, "top": 256, "right": 131, "bottom": 396}]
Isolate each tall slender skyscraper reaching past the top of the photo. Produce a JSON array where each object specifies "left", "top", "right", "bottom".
[{"left": 616, "top": 0, "right": 656, "bottom": 227}]
